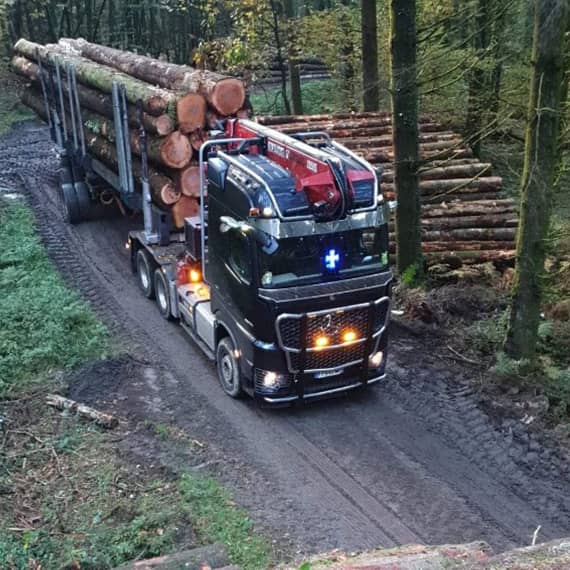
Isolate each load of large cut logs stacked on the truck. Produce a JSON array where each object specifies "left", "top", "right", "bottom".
[{"left": 12, "top": 39, "right": 246, "bottom": 227}]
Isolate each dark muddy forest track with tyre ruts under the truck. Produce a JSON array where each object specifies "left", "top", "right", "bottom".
[{"left": 0, "top": 123, "right": 570, "bottom": 551}]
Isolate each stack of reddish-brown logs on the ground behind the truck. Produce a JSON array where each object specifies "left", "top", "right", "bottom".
[{"left": 258, "top": 113, "right": 518, "bottom": 268}]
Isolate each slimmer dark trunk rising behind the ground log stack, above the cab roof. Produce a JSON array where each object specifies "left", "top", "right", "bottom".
[{"left": 361, "top": 0, "right": 380, "bottom": 111}]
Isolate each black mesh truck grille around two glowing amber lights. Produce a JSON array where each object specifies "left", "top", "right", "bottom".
[{"left": 276, "top": 297, "right": 390, "bottom": 372}]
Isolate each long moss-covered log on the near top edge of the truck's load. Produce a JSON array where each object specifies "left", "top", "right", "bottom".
[{"left": 14, "top": 39, "right": 176, "bottom": 116}]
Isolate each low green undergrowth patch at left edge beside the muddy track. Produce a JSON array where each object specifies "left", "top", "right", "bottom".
[{"left": 0, "top": 202, "right": 110, "bottom": 399}]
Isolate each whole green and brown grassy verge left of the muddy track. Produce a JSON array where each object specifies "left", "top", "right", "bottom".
[{"left": 0, "top": 198, "right": 270, "bottom": 570}]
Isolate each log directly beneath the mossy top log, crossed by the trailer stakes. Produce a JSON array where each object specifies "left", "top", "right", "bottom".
[{"left": 12, "top": 56, "right": 174, "bottom": 136}]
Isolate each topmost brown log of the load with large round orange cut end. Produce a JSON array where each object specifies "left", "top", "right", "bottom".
[{"left": 60, "top": 39, "right": 245, "bottom": 116}]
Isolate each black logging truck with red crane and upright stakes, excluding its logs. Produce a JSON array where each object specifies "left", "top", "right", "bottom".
[{"left": 37, "top": 58, "right": 392, "bottom": 405}]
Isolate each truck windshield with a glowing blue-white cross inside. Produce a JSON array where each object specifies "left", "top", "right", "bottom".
[{"left": 259, "top": 229, "right": 388, "bottom": 288}]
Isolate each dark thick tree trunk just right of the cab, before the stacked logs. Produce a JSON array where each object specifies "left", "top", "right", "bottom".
[{"left": 390, "top": 0, "right": 423, "bottom": 278}]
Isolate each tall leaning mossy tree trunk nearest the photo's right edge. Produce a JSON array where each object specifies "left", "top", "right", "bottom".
[{"left": 505, "top": 0, "right": 568, "bottom": 360}]
